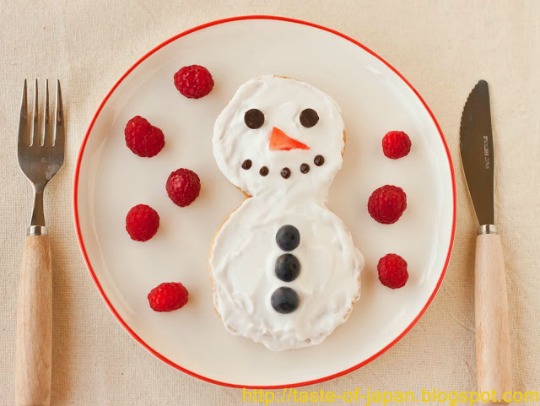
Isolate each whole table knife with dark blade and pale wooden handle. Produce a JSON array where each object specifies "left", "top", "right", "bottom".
[{"left": 460, "top": 80, "right": 512, "bottom": 401}]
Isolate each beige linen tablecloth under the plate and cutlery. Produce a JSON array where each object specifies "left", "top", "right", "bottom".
[{"left": 0, "top": 0, "right": 540, "bottom": 405}]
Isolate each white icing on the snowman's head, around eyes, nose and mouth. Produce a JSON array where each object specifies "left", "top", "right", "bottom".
[{"left": 213, "top": 76, "right": 345, "bottom": 196}]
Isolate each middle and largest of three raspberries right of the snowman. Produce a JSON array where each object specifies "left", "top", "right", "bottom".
[{"left": 368, "top": 185, "right": 407, "bottom": 224}]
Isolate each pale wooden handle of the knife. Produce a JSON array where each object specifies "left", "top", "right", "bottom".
[{"left": 475, "top": 234, "right": 512, "bottom": 399}]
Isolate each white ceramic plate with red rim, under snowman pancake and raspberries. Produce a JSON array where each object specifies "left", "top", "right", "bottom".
[{"left": 74, "top": 16, "right": 455, "bottom": 388}]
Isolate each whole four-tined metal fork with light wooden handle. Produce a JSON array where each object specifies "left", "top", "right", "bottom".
[{"left": 15, "top": 80, "right": 65, "bottom": 406}]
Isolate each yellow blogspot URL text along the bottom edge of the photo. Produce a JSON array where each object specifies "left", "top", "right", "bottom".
[{"left": 242, "top": 388, "right": 540, "bottom": 406}]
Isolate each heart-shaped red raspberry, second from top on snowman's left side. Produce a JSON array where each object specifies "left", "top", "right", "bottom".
[{"left": 124, "top": 116, "right": 165, "bottom": 158}]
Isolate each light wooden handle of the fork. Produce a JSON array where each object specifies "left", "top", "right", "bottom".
[{"left": 15, "top": 235, "right": 52, "bottom": 406}]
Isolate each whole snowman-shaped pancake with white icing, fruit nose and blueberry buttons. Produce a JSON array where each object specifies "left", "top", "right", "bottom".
[{"left": 210, "top": 76, "right": 364, "bottom": 351}]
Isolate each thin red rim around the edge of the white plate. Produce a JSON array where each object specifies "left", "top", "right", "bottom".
[{"left": 73, "top": 15, "right": 456, "bottom": 389}]
